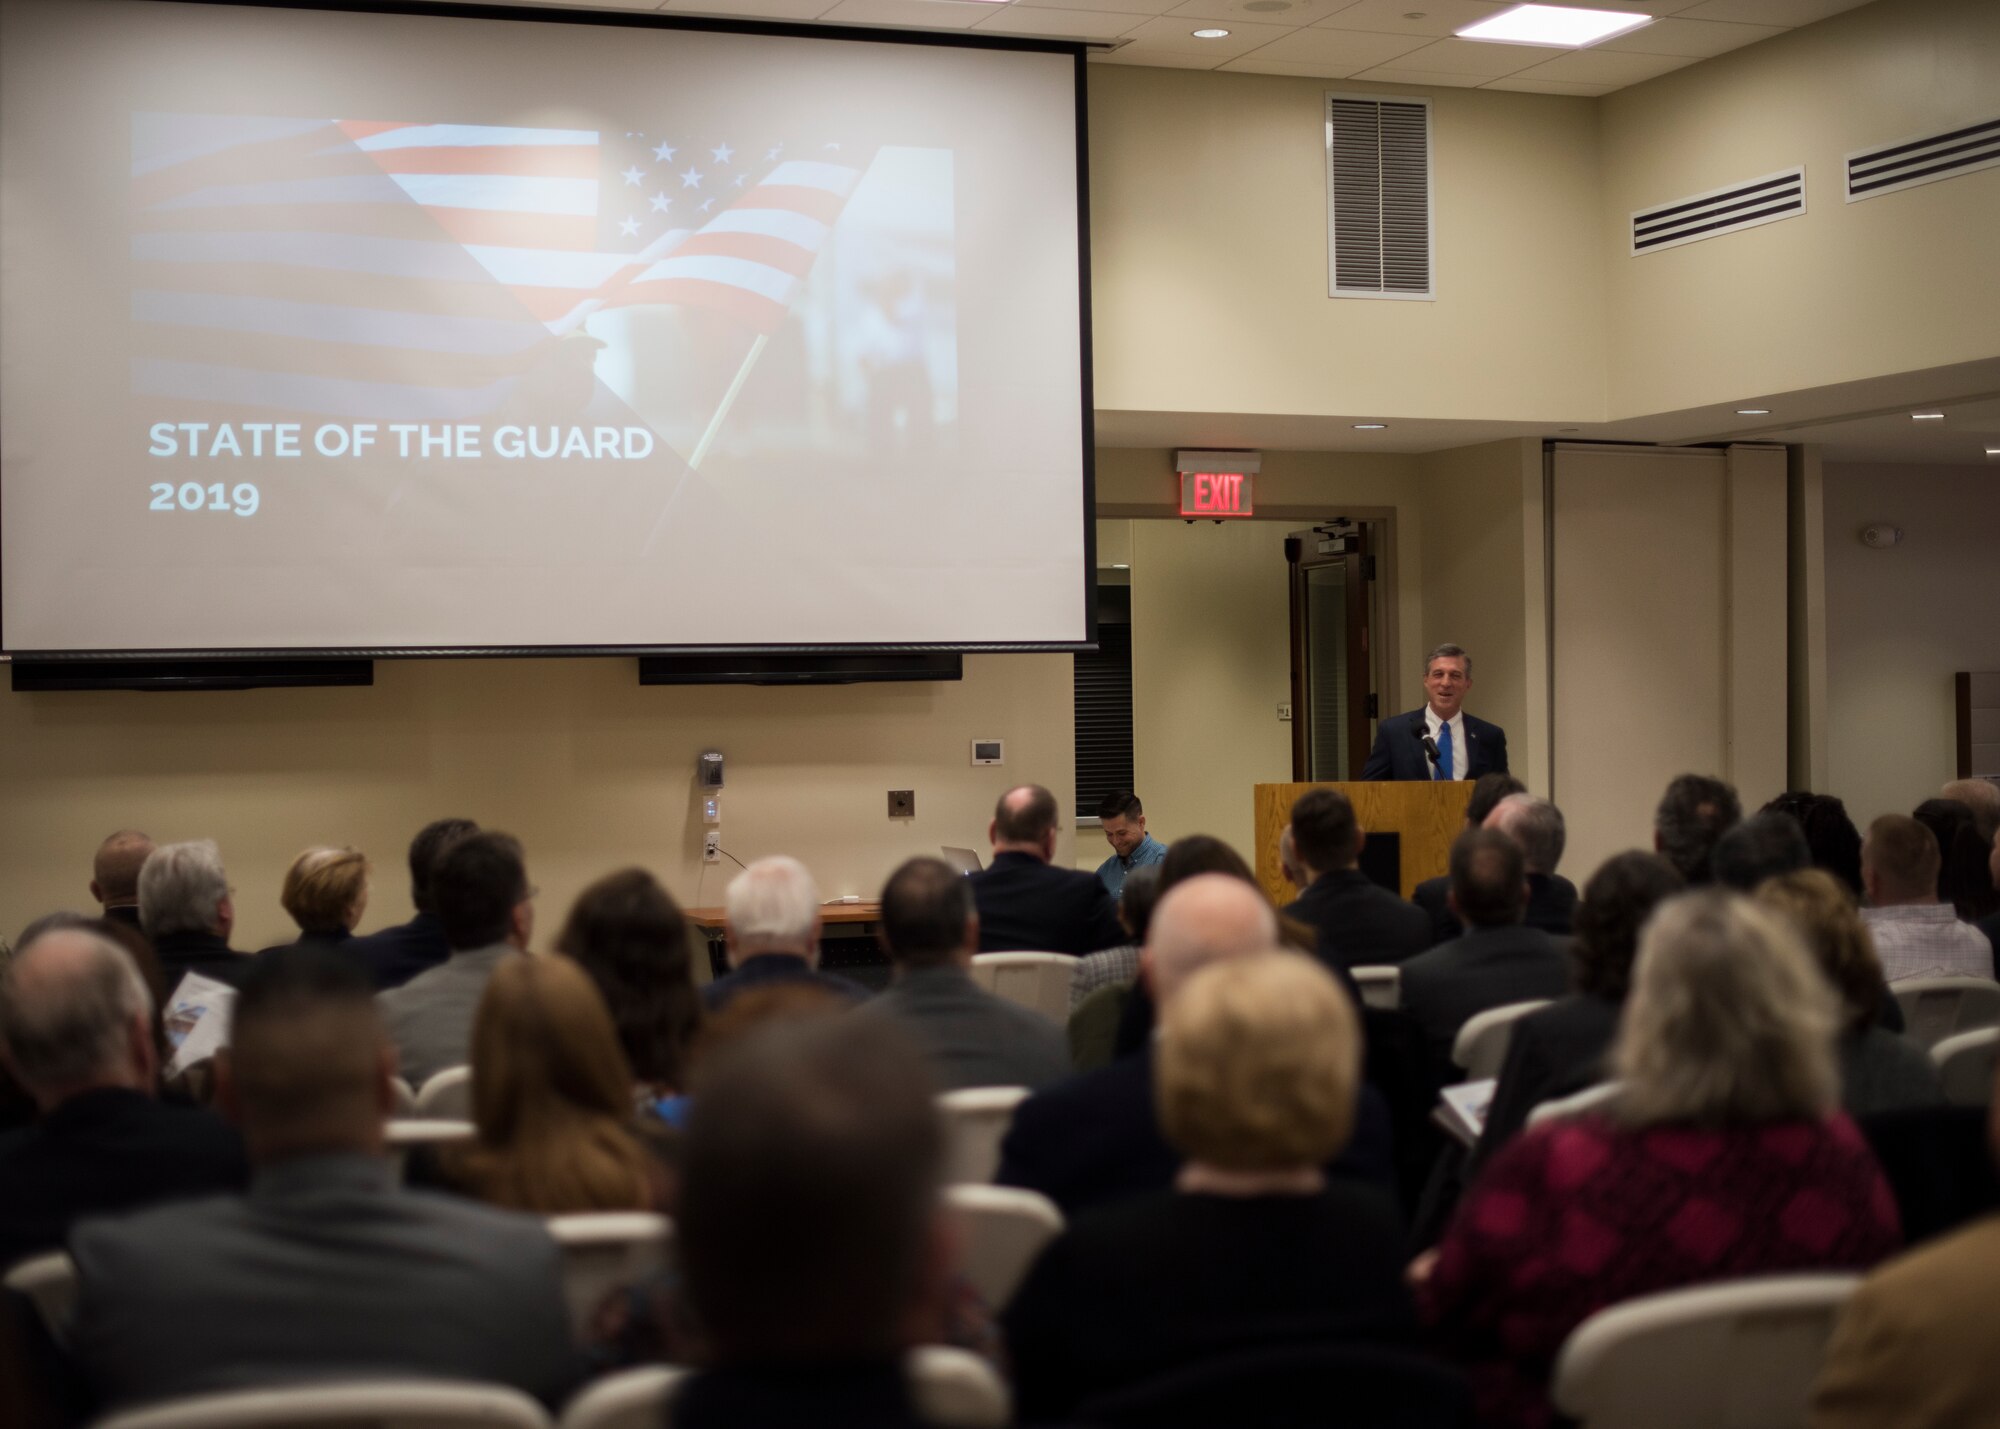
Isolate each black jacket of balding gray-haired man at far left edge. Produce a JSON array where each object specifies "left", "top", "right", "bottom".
[{"left": 0, "top": 1087, "right": 250, "bottom": 1269}]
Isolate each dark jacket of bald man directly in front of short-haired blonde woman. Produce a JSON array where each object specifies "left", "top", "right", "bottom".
[{"left": 994, "top": 1045, "right": 1396, "bottom": 1217}]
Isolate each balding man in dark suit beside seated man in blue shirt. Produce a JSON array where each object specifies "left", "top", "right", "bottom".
[{"left": 970, "top": 785, "right": 1124, "bottom": 957}]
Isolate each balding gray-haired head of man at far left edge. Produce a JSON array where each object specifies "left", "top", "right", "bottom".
[{"left": 0, "top": 927, "right": 156, "bottom": 1111}]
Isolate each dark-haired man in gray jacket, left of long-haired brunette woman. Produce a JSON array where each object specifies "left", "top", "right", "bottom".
[{"left": 380, "top": 833, "right": 534, "bottom": 1087}]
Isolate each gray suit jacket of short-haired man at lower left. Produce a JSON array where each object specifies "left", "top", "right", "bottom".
[{"left": 70, "top": 1155, "right": 580, "bottom": 1407}]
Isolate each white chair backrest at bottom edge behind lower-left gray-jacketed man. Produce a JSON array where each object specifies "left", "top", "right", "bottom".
[{"left": 96, "top": 1379, "right": 550, "bottom": 1429}]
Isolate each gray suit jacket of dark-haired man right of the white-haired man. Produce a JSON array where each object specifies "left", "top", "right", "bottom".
[{"left": 860, "top": 967, "right": 1072, "bottom": 1091}]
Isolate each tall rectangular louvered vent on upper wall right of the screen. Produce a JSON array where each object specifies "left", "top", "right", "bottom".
[{"left": 1326, "top": 94, "right": 1432, "bottom": 298}]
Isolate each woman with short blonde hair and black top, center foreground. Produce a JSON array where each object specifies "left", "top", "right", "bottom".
[{"left": 1002, "top": 951, "right": 1416, "bottom": 1423}]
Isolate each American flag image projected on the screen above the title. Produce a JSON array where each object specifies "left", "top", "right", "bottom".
[{"left": 132, "top": 114, "right": 872, "bottom": 420}]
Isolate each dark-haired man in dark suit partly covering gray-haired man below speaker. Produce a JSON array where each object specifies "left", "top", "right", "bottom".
[{"left": 1402, "top": 829, "right": 1570, "bottom": 1077}]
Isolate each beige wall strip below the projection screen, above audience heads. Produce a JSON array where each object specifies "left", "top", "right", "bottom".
[{"left": 0, "top": 654, "right": 1080, "bottom": 949}]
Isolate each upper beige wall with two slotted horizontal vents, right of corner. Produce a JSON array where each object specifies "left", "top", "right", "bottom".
[{"left": 1600, "top": 0, "right": 2000, "bottom": 418}]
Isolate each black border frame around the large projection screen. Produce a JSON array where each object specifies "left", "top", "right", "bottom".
[{"left": 0, "top": 0, "right": 1098, "bottom": 662}]
